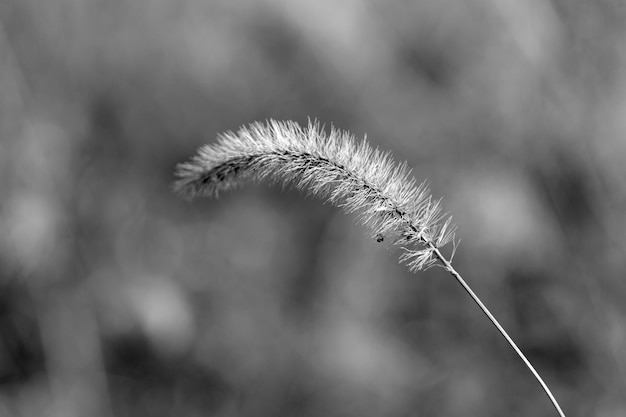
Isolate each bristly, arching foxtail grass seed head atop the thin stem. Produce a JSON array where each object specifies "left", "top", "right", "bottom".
[{"left": 174, "top": 120, "right": 456, "bottom": 270}]
